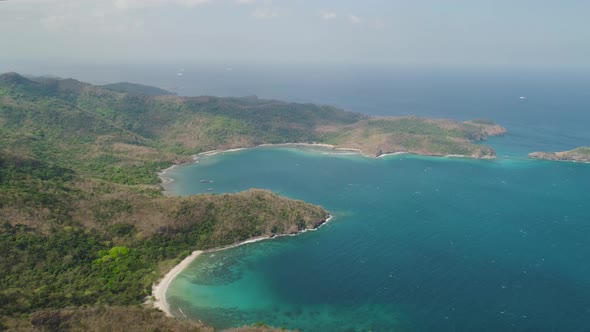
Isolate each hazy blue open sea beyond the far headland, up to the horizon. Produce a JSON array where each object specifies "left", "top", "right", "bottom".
[{"left": 6, "top": 61, "right": 590, "bottom": 155}]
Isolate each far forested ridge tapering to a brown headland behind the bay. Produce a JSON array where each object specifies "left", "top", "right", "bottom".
[{"left": 0, "top": 73, "right": 505, "bottom": 184}]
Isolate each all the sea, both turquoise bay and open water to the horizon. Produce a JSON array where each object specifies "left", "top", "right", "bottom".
[{"left": 5, "top": 65, "right": 590, "bottom": 332}]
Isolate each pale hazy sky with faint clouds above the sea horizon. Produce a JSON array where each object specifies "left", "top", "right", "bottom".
[{"left": 0, "top": 0, "right": 590, "bottom": 67}]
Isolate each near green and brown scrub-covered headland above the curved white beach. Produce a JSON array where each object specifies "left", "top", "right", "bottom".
[{"left": 0, "top": 152, "right": 327, "bottom": 316}]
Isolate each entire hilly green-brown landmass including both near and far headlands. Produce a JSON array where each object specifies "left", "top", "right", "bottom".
[{"left": 0, "top": 73, "right": 506, "bottom": 331}]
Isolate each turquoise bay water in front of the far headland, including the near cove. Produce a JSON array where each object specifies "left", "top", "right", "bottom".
[{"left": 167, "top": 146, "right": 590, "bottom": 331}]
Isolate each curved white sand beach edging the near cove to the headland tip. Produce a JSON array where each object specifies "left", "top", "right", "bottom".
[{"left": 147, "top": 214, "right": 334, "bottom": 322}]
